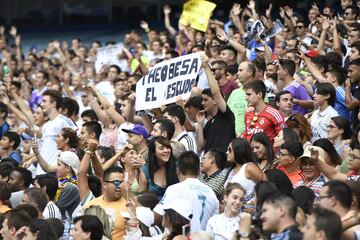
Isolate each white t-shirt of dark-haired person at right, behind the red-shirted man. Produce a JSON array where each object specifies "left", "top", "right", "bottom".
[{"left": 311, "top": 106, "right": 339, "bottom": 142}]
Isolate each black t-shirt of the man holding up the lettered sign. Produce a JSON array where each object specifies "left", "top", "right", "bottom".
[{"left": 204, "top": 106, "right": 236, "bottom": 152}]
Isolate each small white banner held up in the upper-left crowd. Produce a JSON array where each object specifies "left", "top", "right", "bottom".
[{"left": 95, "top": 43, "right": 124, "bottom": 73}]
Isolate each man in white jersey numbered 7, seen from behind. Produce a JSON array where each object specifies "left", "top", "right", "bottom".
[{"left": 154, "top": 151, "right": 219, "bottom": 232}]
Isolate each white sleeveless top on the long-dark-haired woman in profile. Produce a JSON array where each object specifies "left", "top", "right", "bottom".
[{"left": 224, "top": 163, "right": 256, "bottom": 202}]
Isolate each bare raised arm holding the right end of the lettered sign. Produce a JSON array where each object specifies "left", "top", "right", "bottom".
[{"left": 200, "top": 54, "right": 226, "bottom": 112}]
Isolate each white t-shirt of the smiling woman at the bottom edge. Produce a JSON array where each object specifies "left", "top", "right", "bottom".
[{"left": 206, "top": 213, "right": 240, "bottom": 240}]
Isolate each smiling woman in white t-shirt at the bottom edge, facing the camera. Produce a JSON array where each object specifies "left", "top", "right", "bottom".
[{"left": 206, "top": 183, "right": 245, "bottom": 240}]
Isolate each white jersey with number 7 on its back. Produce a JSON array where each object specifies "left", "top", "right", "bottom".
[{"left": 154, "top": 178, "right": 219, "bottom": 232}]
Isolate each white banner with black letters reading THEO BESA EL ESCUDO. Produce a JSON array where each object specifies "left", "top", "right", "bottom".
[{"left": 135, "top": 52, "right": 201, "bottom": 111}]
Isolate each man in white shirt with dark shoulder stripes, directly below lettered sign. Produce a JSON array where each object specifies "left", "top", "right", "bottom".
[{"left": 164, "top": 104, "right": 197, "bottom": 152}]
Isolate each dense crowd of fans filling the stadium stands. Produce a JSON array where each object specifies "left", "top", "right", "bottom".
[{"left": 0, "top": 0, "right": 360, "bottom": 240}]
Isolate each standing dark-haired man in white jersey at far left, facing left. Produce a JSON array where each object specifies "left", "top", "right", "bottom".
[{"left": 36, "top": 90, "right": 74, "bottom": 175}]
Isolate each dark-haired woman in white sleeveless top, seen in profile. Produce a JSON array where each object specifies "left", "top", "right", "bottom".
[{"left": 224, "top": 138, "right": 265, "bottom": 202}]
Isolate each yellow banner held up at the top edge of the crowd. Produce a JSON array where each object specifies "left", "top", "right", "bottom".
[{"left": 180, "top": 0, "right": 216, "bottom": 32}]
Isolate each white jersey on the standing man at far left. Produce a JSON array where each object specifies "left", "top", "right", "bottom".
[{"left": 36, "top": 114, "right": 76, "bottom": 175}]
